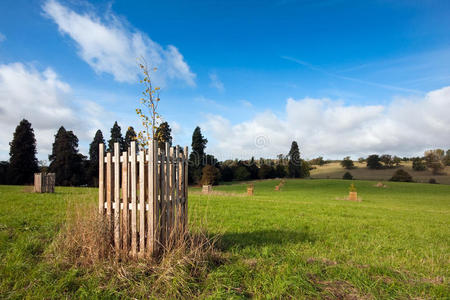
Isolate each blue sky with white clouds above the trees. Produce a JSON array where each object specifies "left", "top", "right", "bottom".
[{"left": 0, "top": 0, "right": 450, "bottom": 160}]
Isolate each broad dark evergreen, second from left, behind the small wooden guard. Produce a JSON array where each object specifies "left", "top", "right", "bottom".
[{"left": 48, "top": 126, "right": 86, "bottom": 186}]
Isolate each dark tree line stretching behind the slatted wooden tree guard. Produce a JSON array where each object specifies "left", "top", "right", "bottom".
[{"left": 0, "top": 119, "right": 309, "bottom": 186}]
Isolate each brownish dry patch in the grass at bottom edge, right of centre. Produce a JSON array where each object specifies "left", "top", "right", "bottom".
[{"left": 308, "top": 274, "right": 373, "bottom": 300}]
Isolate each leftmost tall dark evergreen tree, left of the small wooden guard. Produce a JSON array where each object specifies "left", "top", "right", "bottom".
[{"left": 8, "top": 119, "right": 39, "bottom": 184}]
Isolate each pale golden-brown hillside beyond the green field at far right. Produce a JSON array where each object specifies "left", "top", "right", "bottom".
[{"left": 311, "top": 161, "right": 450, "bottom": 184}]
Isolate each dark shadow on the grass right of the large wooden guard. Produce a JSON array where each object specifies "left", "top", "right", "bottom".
[{"left": 219, "top": 229, "right": 316, "bottom": 250}]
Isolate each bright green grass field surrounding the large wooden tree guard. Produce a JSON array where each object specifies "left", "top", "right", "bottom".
[{"left": 0, "top": 179, "right": 450, "bottom": 299}]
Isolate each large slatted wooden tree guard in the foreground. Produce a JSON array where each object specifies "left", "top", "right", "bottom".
[{"left": 99, "top": 142, "right": 188, "bottom": 257}]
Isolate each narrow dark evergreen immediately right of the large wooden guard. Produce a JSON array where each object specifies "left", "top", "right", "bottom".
[{"left": 188, "top": 126, "right": 208, "bottom": 183}]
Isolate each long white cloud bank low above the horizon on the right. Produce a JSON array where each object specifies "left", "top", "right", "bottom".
[{"left": 202, "top": 87, "right": 450, "bottom": 159}]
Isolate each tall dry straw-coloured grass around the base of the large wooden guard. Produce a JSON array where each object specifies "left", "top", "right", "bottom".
[{"left": 47, "top": 202, "right": 224, "bottom": 298}]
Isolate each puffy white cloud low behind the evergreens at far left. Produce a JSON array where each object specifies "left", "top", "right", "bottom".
[{"left": 0, "top": 63, "right": 111, "bottom": 160}]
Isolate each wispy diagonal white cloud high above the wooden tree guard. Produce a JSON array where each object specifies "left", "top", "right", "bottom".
[{"left": 43, "top": 0, "right": 196, "bottom": 86}]
